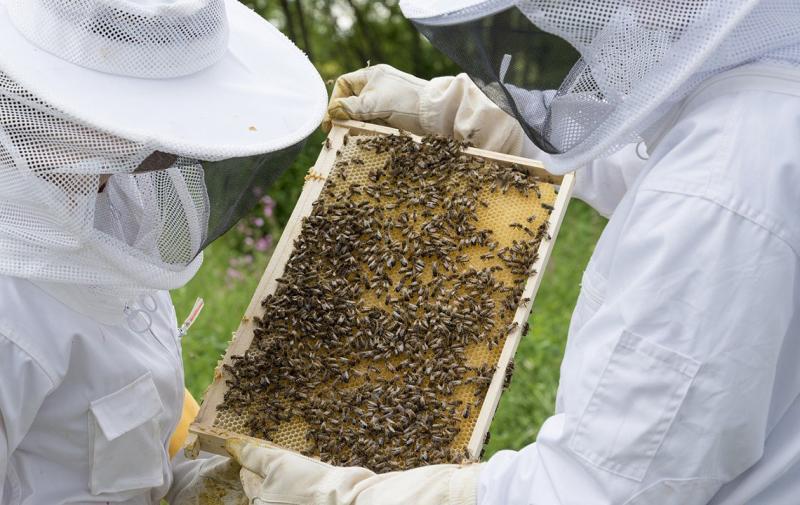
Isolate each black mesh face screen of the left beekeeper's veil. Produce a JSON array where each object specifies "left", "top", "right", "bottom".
[{"left": 201, "top": 140, "right": 305, "bottom": 250}]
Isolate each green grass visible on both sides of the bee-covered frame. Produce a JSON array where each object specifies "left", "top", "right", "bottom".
[{"left": 172, "top": 198, "right": 605, "bottom": 458}]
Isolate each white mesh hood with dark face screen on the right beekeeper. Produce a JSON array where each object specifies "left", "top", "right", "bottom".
[{"left": 401, "top": 0, "right": 800, "bottom": 172}]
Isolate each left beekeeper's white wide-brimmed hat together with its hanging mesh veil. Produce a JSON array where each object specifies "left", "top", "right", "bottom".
[{"left": 0, "top": 0, "right": 327, "bottom": 304}]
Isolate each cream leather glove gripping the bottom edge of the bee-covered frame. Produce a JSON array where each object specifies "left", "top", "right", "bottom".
[{"left": 227, "top": 440, "right": 481, "bottom": 505}]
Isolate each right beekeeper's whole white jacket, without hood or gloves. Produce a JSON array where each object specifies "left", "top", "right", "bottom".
[{"left": 479, "top": 63, "right": 800, "bottom": 505}]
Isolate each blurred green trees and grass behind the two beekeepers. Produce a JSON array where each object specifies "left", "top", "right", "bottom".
[{"left": 172, "top": 0, "right": 605, "bottom": 458}]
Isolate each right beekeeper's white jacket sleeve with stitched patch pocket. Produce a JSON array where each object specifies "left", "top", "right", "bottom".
[{"left": 479, "top": 190, "right": 797, "bottom": 505}]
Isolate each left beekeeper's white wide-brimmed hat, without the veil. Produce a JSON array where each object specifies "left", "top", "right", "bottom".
[{"left": 0, "top": 0, "right": 327, "bottom": 160}]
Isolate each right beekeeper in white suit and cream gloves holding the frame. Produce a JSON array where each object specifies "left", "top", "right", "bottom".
[{"left": 220, "top": 0, "right": 800, "bottom": 505}]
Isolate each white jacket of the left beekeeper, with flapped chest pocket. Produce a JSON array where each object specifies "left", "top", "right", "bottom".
[{"left": 0, "top": 276, "right": 189, "bottom": 505}]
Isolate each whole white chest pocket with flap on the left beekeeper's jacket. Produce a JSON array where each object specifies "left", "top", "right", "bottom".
[{"left": 89, "top": 372, "right": 165, "bottom": 495}]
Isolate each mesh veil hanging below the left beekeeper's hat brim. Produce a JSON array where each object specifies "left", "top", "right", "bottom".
[{"left": 0, "top": 72, "right": 302, "bottom": 299}]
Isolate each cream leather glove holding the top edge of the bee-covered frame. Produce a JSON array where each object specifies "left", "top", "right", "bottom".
[{"left": 322, "top": 65, "right": 526, "bottom": 155}]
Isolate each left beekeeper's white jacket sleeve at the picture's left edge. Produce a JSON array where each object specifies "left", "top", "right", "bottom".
[{"left": 0, "top": 329, "right": 54, "bottom": 503}]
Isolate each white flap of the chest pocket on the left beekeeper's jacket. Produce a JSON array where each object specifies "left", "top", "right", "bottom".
[{"left": 90, "top": 372, "right": 164, "bottom": 440}]
